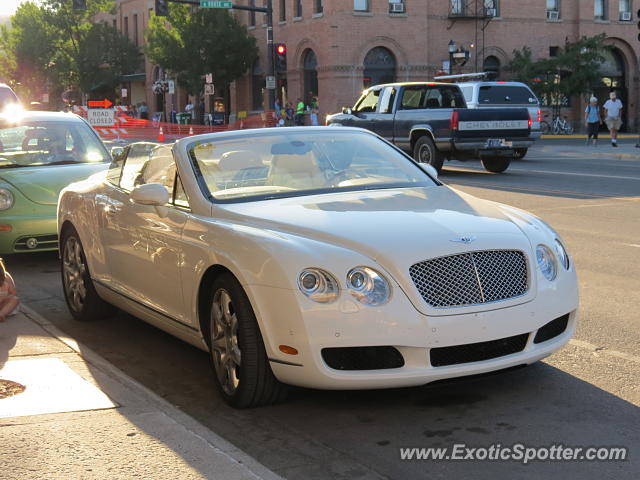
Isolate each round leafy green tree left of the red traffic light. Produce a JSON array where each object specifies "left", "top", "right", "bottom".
[{"left": 145, "top": 4, "right": 258, "bottom": 119}]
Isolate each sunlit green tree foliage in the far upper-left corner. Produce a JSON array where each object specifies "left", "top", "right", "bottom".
[{"left": 0, "top": 0, "right": 140, "bottom": 105}]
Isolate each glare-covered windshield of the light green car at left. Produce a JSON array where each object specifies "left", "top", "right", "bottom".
[{"left": 0, "top": 121, "right": 110, "bottom": 168}]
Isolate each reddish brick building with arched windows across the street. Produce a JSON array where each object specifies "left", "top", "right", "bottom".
[{"left": 104, "top": 0, "right": 640, "bottom": 127}]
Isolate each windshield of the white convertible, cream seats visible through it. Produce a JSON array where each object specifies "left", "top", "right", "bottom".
[{"left": 189, "top": 128, "right": 436, "bottom": 202}]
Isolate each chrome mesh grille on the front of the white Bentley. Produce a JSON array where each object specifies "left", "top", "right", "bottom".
[{"left": 409, "top": 250, "right": 529, "bottom": 307}]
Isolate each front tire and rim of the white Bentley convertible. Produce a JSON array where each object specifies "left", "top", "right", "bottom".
[{"left": 207, "top": 273, "right": 287, "bottom": 408}]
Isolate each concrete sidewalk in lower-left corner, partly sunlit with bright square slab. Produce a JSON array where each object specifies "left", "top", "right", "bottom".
[{"left": 0, "top": 306, "right": 280, "bottom": 480}]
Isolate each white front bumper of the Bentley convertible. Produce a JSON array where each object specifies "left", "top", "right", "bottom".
[{"left": 249, "top": 274, "right": 578, "bottom": 389}]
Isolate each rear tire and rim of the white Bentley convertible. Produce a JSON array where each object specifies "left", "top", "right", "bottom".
[{"left": 60, "top": 227, "right": 114, "bottom": 322}]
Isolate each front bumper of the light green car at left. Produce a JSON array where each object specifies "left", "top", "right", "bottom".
[{"left": 0, "top": 212, "right": 58, "bottom": 255}]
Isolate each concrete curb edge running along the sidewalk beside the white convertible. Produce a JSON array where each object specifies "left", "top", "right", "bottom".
[{"left": 20, "top": 303, "right": 283, "bottom": 480}]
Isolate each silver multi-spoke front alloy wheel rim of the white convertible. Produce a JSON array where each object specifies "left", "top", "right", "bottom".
[{"left": 211, "top": 288, "right": 241, "bottom": 396}]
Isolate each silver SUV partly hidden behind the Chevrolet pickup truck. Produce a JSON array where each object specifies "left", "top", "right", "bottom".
[{"left": 458, "top": 82, "right": 542, "bottom": 158}]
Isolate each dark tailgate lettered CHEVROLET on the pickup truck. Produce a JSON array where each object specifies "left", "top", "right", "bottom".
[{"left": 454, "top": 108, "right": 531, "bottom": 140}]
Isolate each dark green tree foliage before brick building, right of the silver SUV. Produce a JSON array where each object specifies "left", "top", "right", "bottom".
[{"left": 510, "top": 34, "right": 610, "bottom": 104}]
